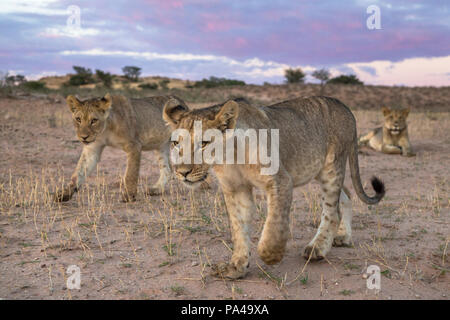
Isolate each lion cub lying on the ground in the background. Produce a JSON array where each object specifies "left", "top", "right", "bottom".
[{"left": 358, "top": 107, "right": 416, "bottom": 157}]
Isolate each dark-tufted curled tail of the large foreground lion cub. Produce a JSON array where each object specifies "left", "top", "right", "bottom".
[{"left": 349, "top": 139, "right": 386, "bottom": 204}]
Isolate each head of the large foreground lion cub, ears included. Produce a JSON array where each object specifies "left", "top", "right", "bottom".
[{"left": 163, "top": 98, "right": 239, "bottom": 187}]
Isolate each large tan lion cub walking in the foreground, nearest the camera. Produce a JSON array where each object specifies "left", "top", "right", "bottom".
[{"left": 163, "top": 97, "right": 384, "bottom": 279}]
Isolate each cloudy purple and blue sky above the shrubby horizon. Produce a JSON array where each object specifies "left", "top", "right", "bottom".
[{"left": 0, "top": 0, "right": 450, "bottom": 86}]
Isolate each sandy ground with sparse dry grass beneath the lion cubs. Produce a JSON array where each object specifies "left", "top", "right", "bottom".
[{"left": 0, "top": 92, "right": 450, "bottom": 299}]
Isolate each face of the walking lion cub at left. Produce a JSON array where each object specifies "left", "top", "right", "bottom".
[{"left": 66, "top": 94, "right": 112, "bottom": 144}]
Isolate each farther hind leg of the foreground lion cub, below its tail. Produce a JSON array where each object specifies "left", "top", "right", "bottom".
[{"left": 333, "top": 187, "right": 353, "bottom": 246}]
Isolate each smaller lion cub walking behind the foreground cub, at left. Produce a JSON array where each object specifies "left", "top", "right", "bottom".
[{"left": 54, "top": 93, "right": 178, "bottom": 202}]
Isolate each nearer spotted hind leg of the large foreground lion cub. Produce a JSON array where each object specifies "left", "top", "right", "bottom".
[{"left": 303, "top": 154, "right": 345, "bottom": 260}]
